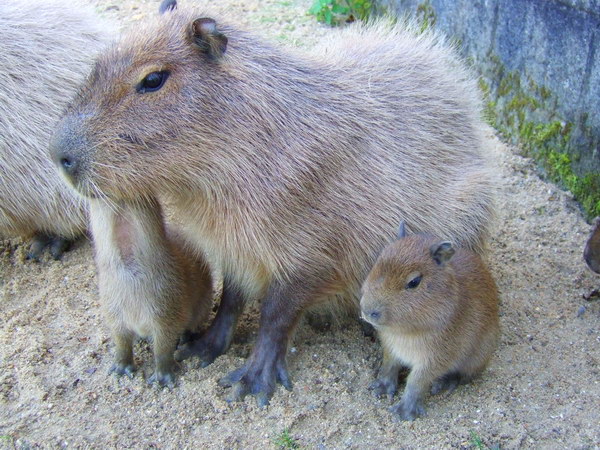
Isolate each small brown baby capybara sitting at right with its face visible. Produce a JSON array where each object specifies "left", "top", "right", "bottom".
[{"left": 360, "top": 226, "right": 500, "bottom": 420}]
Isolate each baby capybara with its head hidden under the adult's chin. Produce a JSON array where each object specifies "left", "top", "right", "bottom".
[{"left": 89, "top": 199, "right": 212, "bottom": 386}]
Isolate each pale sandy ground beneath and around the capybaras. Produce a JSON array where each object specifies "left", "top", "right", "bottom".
[{"left": 0, "top": 0, "right": 600, "bottom": 449}]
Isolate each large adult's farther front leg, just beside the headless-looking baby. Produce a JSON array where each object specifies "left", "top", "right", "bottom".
[{"left": 175, "top": 281, "right": 246, "bottom": 367}]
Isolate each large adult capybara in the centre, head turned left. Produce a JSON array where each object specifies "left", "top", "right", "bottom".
[{"left": 52, "top": 2, "right": 494, "bottom": 404}]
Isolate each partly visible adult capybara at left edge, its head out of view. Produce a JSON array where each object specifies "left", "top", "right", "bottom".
[{"left": 0, "top": 0, "right": 110, "bottom": 258}]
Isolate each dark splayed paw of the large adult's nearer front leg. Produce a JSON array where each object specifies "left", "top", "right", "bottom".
[{"left": 219, "top": 359, "right": 292, "bottom": 408}]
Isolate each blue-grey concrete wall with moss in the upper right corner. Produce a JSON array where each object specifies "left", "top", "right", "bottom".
[{"left": 378, "top": 0, "right": 600, "bottom": 175}]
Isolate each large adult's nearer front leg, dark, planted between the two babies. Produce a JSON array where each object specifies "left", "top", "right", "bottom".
[{"left": 219, "top": 281, "right": 315, "bottom": 407}]
